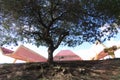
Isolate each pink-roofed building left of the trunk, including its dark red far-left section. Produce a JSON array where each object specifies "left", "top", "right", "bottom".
[{"left": 1, "top": 45, "right": 47, "bottom": 63}]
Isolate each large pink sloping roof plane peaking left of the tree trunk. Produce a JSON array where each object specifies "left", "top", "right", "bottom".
[{"left": 9, "top": 45, "right": 47, "bottom": 62}]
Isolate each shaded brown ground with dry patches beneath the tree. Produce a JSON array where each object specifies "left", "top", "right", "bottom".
[{"left": 0, "top": 59, "right": 120, "bottom": 80}]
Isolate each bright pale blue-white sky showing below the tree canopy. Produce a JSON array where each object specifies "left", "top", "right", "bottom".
[{"left": 2, "top": 24, "right": 120, "bottom": 61}]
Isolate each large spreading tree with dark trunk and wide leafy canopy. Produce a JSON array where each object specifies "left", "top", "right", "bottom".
[{"left": 0, "top": 0, "right": 120, "bottom": 63}]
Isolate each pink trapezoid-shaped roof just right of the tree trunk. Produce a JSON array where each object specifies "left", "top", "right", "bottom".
[{"left": 54, "top": 50, "right": 82, "bottom": 61}]
